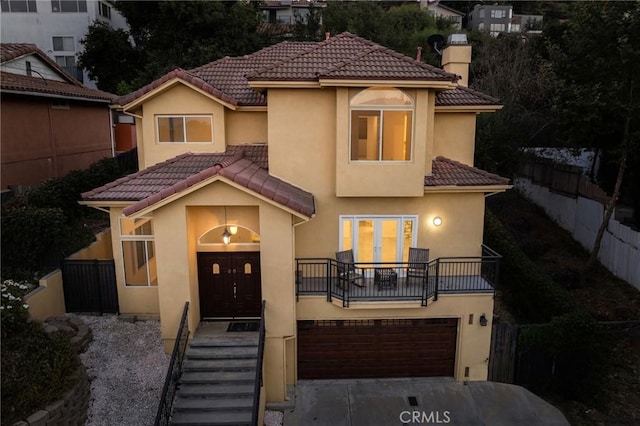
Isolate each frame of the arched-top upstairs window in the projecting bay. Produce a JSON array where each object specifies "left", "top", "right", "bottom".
[{"left": 348, "top": 87, "right": 416, "bottom": 164}]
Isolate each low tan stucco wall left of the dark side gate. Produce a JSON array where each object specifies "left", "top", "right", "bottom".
[{"left": 24, "top": 269, "right": 66, "bottom": 321}]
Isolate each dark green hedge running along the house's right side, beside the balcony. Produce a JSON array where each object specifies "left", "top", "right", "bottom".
[{"left": 484, "top": 211, "right": 575, "bottom": 324}]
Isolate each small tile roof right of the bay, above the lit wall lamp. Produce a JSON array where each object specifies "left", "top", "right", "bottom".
[{"left": 424, "top": 157, "right": 509, "bottom": 187}]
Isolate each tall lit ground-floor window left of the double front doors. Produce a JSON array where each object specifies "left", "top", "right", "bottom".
[{"left": 120, "top": 217, "right": 158, "bottom": 287}]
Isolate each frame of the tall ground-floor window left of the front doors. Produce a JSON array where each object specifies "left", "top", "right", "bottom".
[{"left": 118, "top": 217, "right": 158, "bottom": 288}]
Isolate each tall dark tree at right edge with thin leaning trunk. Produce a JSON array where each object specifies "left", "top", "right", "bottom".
[{"left": 549, "top": 2, "right": 640, "bottom": 282}]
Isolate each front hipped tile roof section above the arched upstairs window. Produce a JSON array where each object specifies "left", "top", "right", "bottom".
[{"left": 247, "top": 32, "right": 457, "bottom": 81}]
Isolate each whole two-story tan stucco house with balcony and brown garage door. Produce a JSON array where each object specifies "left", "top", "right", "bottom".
[{"left": 82, "top": 33, "right": 510, "bottom": 401}]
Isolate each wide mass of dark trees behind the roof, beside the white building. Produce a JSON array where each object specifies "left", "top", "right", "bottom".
[{"left": 82, "top": 1, "right": 270, "bottom": 91}]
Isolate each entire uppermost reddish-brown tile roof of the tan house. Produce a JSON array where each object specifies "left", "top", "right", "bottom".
[{"left": 119, "top": 33, "right": 499, "bottom": 106}]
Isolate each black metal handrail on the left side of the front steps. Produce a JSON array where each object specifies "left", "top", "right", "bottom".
[{"left": 154, "top": 302, "right": 190, "bottom": 426}]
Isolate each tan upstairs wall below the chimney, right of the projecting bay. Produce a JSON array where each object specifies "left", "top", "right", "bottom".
[{"left": 433, "top": 112, "right": 476, "bottom": 166}]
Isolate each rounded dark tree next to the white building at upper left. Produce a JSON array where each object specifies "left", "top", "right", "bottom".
[{"left": 79, "top": 21, "right": 142, "bottom": 94}]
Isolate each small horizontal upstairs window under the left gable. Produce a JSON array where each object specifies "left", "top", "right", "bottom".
[{"left": 156, "top": 115, "right": 213, "bottom": 143}]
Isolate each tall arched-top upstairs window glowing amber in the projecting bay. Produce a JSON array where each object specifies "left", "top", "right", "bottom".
[{"left": 350, "top": 88, "right": 414, "bottom": 161}]
